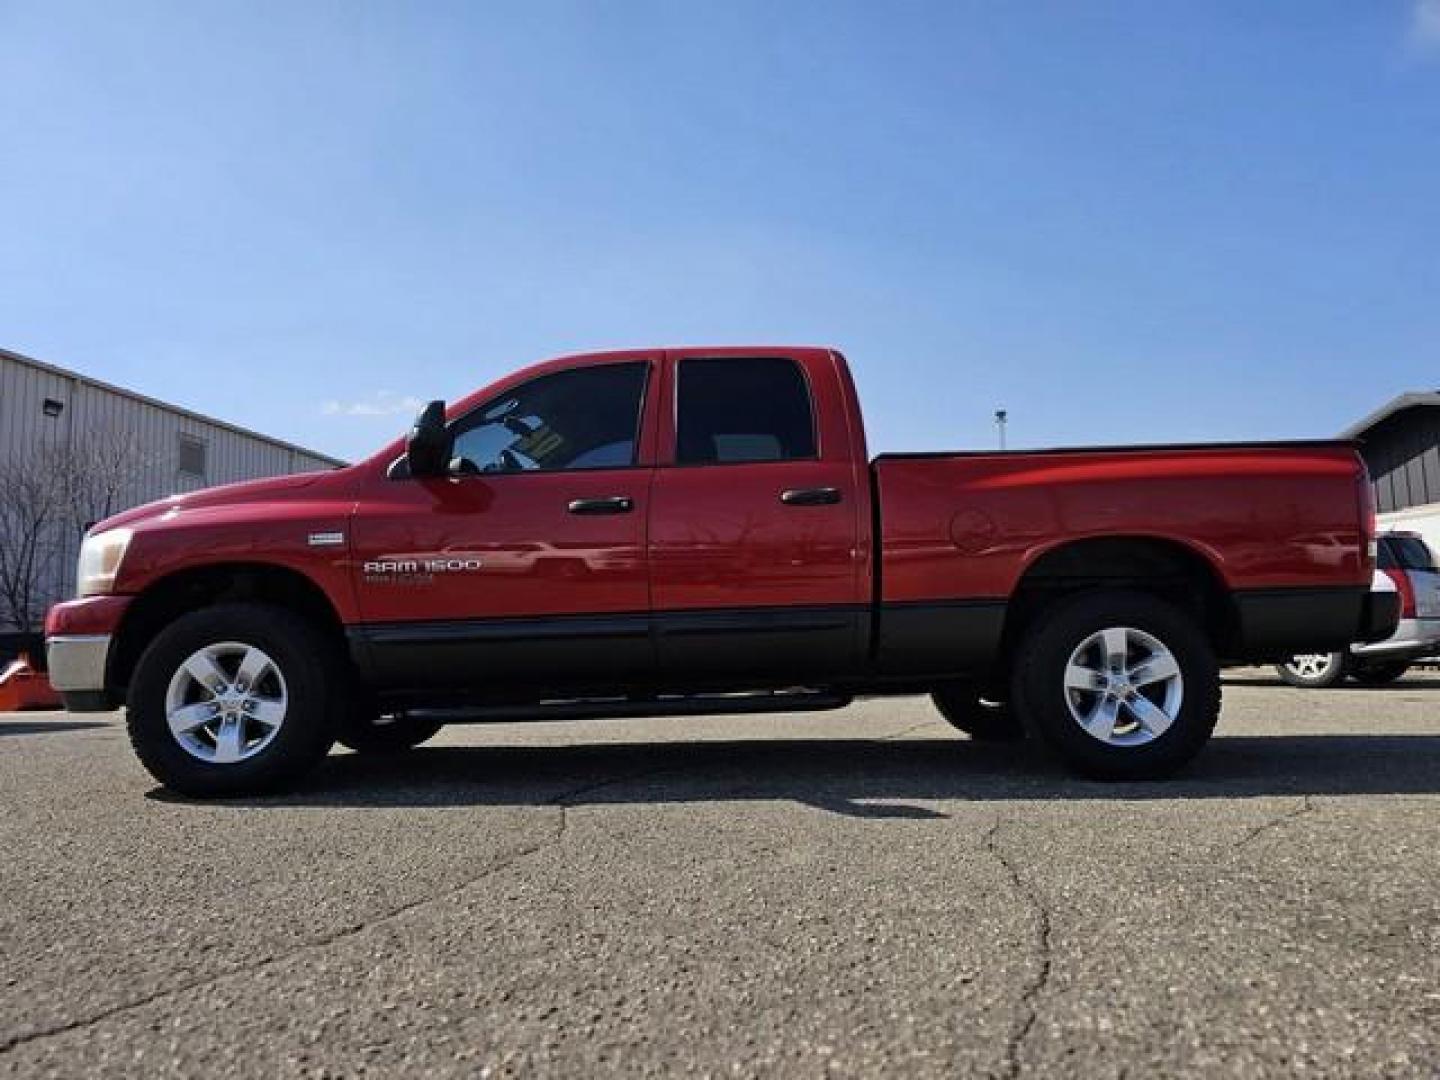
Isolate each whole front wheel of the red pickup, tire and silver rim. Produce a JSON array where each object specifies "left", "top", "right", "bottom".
[{"left": 127, "top": 603, "right": 340, "bottom": 798}]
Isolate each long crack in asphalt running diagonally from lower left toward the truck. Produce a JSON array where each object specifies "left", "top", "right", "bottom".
[{"left": 0, "top": 766, "right": 675, "bottom": 1057}]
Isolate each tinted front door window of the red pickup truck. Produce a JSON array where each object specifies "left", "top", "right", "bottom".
[{"left": 454, "top": 363, "right": 648, "bottom": 472}]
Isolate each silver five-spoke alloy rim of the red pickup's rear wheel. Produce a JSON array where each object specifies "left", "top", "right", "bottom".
[{"left": 1064, "top": 626, "right": 1185, "bottom": 746}]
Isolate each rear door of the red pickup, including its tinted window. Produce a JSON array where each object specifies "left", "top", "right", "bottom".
[{"left": 649, "top": 353, "right": 868, "bottom": 684}]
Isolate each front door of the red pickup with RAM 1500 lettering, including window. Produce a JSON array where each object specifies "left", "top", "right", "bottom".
[{"left": 353, "top": 359, "right": 658, "bottom": 691}]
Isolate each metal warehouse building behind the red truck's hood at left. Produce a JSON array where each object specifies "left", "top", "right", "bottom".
[{"left": 0, "top": 348, "right": 344, "bottom": 631}]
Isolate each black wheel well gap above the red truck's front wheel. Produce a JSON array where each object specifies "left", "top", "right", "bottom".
[{"left": 105, "top": 563, "right": 344, "bottom": 690}]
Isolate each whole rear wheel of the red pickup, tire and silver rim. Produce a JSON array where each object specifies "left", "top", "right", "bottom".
[{"left": 1011, "top": 590, "right": 1220, "bottom": 780}]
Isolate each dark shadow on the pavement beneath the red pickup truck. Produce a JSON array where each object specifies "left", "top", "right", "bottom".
[{"left": 194, "top": 734, "right": 1440, "bottom": 818}]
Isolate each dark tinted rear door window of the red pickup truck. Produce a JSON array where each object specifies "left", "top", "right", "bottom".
[{"left": 675, "top": 359, "right": 815, "bottom": 465}]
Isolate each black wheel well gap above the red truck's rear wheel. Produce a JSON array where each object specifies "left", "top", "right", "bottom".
[{"left": 1002, "top": 537, "right": 1238, "bottom": 658}]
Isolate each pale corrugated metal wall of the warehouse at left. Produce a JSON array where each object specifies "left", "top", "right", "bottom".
[{"left": 0, "top": 351, "right": 337, "bottom": 629}]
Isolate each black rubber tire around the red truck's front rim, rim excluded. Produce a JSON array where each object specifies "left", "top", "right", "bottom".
[{"left": 127, "top": 603, "right": 344, "bottom": 799}]
